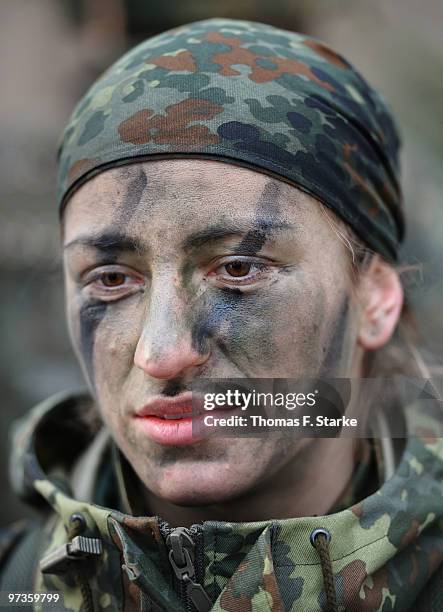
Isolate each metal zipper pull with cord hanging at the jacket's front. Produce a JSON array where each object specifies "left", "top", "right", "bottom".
[{"left": 166, "top": 527, "right": 212, "bottom": 612}]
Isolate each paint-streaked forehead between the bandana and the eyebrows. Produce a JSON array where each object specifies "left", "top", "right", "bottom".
[{"left": 64, "top": 159, "right": 324, "bottom": 241}]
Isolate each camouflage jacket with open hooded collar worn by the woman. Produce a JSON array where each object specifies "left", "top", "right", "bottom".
[{"left": 2, "top": 395, "right": 443, "bottom": 612}]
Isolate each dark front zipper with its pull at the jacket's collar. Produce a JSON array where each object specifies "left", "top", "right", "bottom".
[{"left": 160, "top": 523, "right": 212, "bottom": 612}]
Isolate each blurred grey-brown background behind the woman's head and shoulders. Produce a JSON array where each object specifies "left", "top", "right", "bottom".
[{"left": 0, "top": 0, "right": 443, "bottom": 525}]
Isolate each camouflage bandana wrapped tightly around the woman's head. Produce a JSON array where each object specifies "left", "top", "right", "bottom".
[{"left": 58, "top": 19, "right": 404, "bottom": 260}]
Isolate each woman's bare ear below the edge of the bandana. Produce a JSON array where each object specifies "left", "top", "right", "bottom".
[{"left": 357, "top": 255, "right": 403, "bottom": 350}]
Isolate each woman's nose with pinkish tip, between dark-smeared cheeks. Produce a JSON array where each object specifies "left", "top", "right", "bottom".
[{"left": 134, "top": 279, "right": 210, "bottom": 380}]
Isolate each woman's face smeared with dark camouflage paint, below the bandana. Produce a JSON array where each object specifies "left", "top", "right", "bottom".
[{"left": 64, "top": 160, "right": 356, "bottom": 505}]
